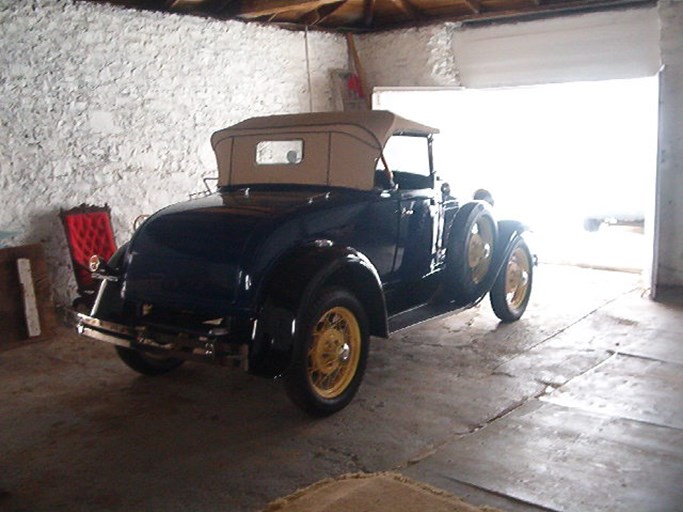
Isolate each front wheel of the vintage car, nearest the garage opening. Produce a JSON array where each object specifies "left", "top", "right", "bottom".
[{"left": 490, "top": 238, "right": 533, "bottom": 322}]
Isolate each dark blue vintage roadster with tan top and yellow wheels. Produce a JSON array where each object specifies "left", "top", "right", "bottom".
[{"left": 78, "top": 111, "right": 533, "bottom": 415}]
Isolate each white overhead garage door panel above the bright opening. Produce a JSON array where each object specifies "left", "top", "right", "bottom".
[{"left": 453, "top": 7, "right": 660, "bottom": 88}]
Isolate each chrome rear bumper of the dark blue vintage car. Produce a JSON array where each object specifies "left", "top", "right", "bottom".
[{"left": 68, "top": 311, "right": 249, "bottom": 371}]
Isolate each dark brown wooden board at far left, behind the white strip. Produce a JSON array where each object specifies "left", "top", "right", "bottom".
[{"left": 0, "top": 244, "right": 57, "bottom": 351}]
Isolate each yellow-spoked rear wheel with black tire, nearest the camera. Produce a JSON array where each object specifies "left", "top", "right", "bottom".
[{"left": 284, "top": 288, "right": 370, "bottom": 416}]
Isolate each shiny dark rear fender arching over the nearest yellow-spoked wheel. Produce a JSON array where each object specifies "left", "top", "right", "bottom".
[{"left": 249, "top": 241, "right": 389, "bottom": 376}]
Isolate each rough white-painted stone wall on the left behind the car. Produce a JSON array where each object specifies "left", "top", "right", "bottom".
[{"left": 0, "top": 0, "right": 348, "bottom": 303}]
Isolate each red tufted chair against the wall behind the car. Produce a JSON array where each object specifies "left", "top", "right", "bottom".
[{"left": 59, "top": 203, "right": 116, "bottom": 310}]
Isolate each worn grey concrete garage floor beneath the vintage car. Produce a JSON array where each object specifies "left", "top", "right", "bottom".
[{"left": 0, "top": 265, "right": 683, "bottom": 512}]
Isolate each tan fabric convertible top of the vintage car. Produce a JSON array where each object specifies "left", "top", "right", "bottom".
[{"left": 211, "top": 110, "right": 438, "bottom": 190}]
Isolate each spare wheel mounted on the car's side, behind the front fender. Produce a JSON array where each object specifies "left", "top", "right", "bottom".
[{"left": 444, "top": 201, "right": 498, "bottom": 303}]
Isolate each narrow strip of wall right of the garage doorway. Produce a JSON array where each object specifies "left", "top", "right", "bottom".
[{"left": 654, "top": 0, "right": 683, "bottom": 292}]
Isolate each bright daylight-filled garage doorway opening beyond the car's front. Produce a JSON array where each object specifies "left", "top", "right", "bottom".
[{"left": 374, "top": 77, "right": 658, "bottom": 271}]
